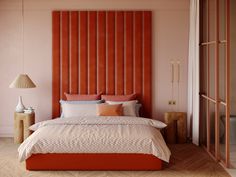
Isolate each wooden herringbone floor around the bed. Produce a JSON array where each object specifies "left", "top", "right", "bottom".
[{"left": 0, "top": 138, "right": 229, "bottom": 177}]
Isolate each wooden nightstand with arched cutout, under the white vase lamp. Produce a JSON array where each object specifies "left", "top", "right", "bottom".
[{"left": 14, "top": 112, "right": 35, "bottom": 143}]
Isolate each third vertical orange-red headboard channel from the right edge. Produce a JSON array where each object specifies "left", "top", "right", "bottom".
[{"left": 124, "top": 12, "right": 133, "bottom": 94}]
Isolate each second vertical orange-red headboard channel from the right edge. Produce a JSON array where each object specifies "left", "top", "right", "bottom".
[{"left": 134, "top": 11, "right": 142, "bottom": 101}]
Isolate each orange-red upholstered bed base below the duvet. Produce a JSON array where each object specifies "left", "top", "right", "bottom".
[{"left": 26, "top": 154, "right": 162, "bottom": 170}]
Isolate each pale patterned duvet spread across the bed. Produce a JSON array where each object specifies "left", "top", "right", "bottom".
[{"left": 18, "top": 116, "right": 170, "bottom": 162}]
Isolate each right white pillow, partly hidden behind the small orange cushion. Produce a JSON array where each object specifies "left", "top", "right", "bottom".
[{"left": 106, "top": 100, "right": 138, "bottom": 117}]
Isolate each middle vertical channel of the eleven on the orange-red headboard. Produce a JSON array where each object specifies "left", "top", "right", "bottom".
[{"left": 97, "top": 11, "right": 106, "bottom": 93}]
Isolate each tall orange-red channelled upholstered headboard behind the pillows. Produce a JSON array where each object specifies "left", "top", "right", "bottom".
[{"left": 52, "top": 11, "right": 152, "bottom": 118}]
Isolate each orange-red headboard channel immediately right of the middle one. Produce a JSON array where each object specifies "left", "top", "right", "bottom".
[{"left": 106, "top": 11, "right": 115, "bottom": 94}]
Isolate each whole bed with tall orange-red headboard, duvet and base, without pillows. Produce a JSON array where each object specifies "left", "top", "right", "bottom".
[{"left": 19, "top": 11, "right": 170, "bottom": 170}]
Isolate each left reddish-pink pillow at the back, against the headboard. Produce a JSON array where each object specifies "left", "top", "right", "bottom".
[{"left": 64, "top": 93, "right": 102, "bottom": 101}]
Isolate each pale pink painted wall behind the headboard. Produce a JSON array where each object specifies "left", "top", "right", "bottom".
[{"left": 0, "top": 0, "right": 189, "bottom": 136}]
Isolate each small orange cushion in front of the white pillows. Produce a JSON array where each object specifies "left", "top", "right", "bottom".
[{"left": 97, "top": 103, "right": 123, "bottom": 116}]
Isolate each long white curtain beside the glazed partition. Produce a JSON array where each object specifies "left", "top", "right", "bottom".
[{"left": 187, "top": 0, "right": 199, "bottom": 145}]
